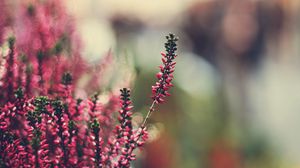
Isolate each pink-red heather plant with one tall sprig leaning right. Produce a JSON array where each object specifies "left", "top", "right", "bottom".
[{"left": 0, "top": 0, "right": 177, "bottom": 167}]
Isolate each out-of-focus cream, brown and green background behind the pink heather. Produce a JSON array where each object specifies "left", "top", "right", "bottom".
[{"left": 66, "top": 0, "right": 300, "bottom": 168}]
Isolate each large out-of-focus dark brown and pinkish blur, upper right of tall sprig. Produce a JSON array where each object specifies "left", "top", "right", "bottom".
[{"left": 183, "top": 0, "right": 285, "bottom": 67}]
